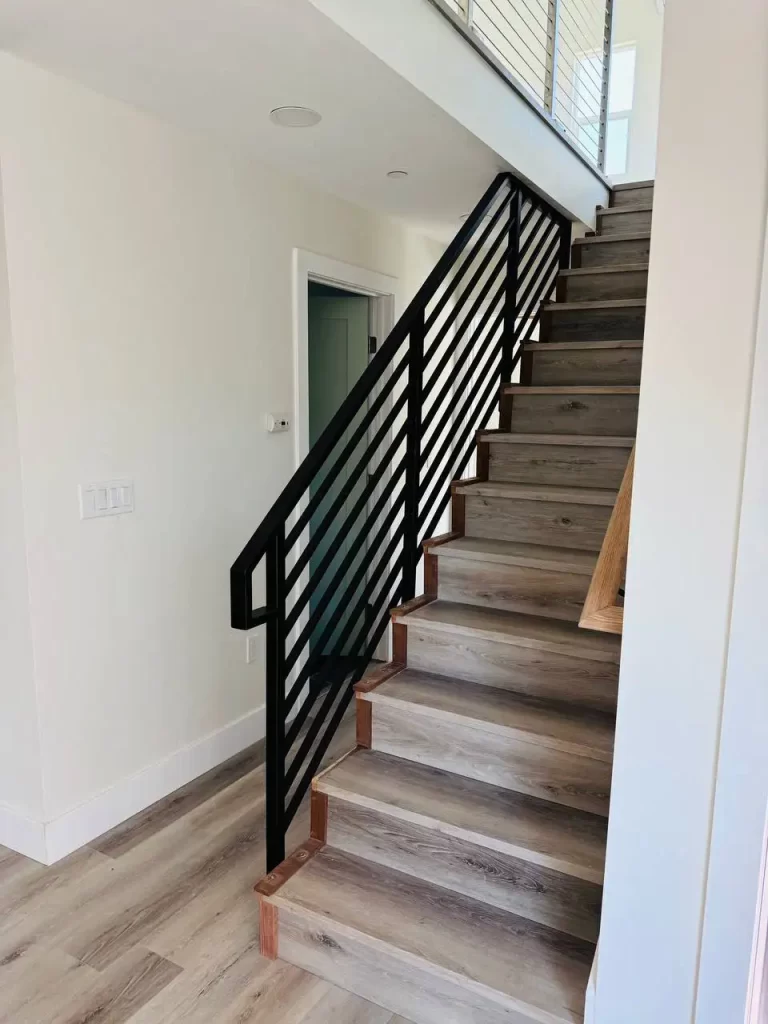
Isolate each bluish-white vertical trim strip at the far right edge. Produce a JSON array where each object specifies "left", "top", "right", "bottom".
[{"left": 695, "top": 207, "right": 768, "bottom": 1024}]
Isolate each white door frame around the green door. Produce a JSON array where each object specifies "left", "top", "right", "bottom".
[{"left": 288, "top": 249, "right": 404, "bottom": 679}]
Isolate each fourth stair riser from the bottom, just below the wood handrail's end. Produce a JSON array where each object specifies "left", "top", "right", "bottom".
[{"left": 408, "top": 629, "right": 618, "bottom": 714}]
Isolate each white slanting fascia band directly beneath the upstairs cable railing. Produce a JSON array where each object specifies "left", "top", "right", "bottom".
[{"left": 311, "top": 0, "right": 608, "bottom": 224}]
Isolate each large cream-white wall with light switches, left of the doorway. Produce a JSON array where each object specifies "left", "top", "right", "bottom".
[{"left": 0, "top": 56, "right": 437, "bottom": 845}]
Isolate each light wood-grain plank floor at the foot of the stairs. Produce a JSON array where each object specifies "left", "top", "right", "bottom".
[{"left": 0, "top": 719, "right": 408, "bottom": 1024}]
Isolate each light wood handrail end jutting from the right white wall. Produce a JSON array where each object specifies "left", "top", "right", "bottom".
[{"left": 579, "top": 447, "right": 635, "bottom": 633}]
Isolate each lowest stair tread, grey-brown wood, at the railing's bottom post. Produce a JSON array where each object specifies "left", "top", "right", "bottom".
[{"left": 270, "top": 847, "right": 594, "bottom": 1024}]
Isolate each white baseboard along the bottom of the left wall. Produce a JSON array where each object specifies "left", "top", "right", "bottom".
[{"left": 0, "top": 706, "right": 266, "bottom": 864}]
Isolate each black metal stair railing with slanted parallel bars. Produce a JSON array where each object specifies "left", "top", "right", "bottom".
[{"left": 230, "top": 173, "right": 570, "bottom": 870}]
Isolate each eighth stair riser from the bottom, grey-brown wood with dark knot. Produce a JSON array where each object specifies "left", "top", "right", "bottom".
[{"left": 512, "top": 393, "right": 638, "bottom": 436}]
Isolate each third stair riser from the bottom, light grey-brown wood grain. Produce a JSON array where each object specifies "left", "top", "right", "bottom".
[{"left": 373, "top": 702, "right": 610, "bottom": 816}]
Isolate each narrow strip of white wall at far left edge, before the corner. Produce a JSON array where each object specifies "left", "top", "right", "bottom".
[{"left": 0, "top": 165, "right": 42, "bottom": 831}]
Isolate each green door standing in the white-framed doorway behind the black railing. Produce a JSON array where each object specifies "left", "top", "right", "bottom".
[{"left": 308, "top": 284, "right": 369, "bottom": 657}]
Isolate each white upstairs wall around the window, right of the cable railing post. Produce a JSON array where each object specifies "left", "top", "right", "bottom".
[{"left": 608, "top": 0, "right": 664, "bottom": 182}]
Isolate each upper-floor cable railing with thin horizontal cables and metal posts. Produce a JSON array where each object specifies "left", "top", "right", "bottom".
[{"left": 431, "top": 0, "right": 613, "bottom": 171}]
